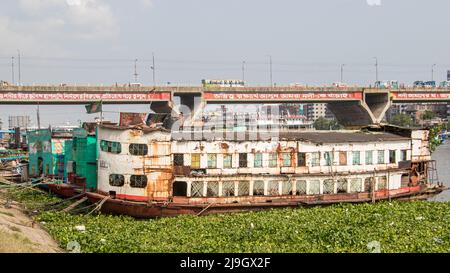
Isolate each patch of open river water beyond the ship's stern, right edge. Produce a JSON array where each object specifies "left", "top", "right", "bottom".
[{"left": 430, "top": 140, "right": 450, "bottom": 202}]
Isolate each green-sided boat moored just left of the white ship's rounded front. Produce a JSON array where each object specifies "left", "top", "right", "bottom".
[{"left": 28, "top": 123, "right": 97, "bottom": 197}]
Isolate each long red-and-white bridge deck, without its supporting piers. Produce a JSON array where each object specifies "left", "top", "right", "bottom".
[{"left": 0, "top": 85, "right": 450, "bottom": 104}]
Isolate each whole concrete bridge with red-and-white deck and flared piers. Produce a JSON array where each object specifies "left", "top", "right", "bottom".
[{"left": 0, "top": 85, "right": 450, "bottom": 127}]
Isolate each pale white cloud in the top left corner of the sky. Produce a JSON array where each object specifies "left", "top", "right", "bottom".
[{"left": 0, "top": 0, "right": 119, "bottom": 55}]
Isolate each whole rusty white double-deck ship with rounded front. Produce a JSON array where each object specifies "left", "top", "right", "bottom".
[{"left": 80, "top": 116, "right": 444, "bottom": 217}]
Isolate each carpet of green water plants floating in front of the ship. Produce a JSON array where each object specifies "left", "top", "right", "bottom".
[{"left": 3, "top": 186, "right": 450, "bottom": 253}]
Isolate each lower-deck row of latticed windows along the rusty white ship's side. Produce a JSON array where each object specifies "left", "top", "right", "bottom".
[{"left": 185, "top": 176, "right": 387, "bottom": 197}]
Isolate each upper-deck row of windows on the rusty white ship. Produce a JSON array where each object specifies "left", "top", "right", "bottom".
[{"left": 100, "top": 140, "right": 408, "bottom": 168}]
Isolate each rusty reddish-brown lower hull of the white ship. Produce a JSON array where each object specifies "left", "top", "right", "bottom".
[{"left": 86, "top": 185, "right": 446, "bottom": 218}]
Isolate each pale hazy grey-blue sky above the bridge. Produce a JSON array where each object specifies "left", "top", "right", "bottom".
[{"left": 0, "top": 0, "right": 450, "bottom": 126}]
